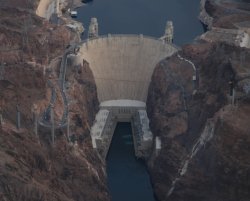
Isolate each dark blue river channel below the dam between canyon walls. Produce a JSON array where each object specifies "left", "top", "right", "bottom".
[{"left": 107, "top": 123, "right": 155, "bottom": 201}]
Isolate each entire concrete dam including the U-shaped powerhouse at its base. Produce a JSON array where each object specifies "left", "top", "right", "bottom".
[{"left": 76, "top": 34, "right": 178, "bottom": 158}]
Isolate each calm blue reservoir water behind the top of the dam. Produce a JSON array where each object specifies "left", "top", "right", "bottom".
[{"left": 77, "top": 0, "right": 203, "bottom": 45}]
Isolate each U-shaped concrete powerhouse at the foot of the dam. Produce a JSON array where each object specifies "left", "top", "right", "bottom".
[{"left": 90, "top": 106, "right": 153, "bottom": 159}]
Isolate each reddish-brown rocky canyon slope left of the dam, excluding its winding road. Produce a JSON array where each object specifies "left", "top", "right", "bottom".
[{"left": 0, "top": 1, "right": 109, "bottom": 201}]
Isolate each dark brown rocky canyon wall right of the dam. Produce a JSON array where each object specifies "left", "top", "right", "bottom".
[{"left": 147, "top": 1, "right": 250, "bottom": 201}]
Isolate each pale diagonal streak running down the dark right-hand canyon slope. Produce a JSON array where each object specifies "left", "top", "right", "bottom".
[{"left": 167, "top": 119, "right": 215, "bottom": 197}]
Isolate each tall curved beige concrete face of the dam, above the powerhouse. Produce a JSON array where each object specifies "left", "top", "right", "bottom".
[{"left": 78, "top": 35, "right": 177, "bottom": 102}]
